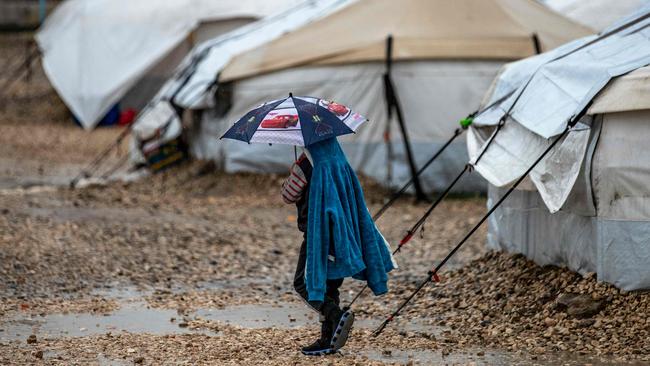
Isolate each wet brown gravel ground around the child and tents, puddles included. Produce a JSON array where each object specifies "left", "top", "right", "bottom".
[{"left": 0, "top": 33, "right": 650, "bottom": 365}]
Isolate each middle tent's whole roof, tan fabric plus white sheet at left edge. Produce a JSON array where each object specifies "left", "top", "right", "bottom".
[{"left": 151, "top": 0, "right": 590, "bottom": 113}]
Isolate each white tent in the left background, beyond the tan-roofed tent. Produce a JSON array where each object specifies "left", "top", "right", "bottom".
[{"left": 36, "top": 0, "right": 291, "bottom": 129}]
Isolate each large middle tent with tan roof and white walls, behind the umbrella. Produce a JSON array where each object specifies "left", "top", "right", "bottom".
[{"left": 139, "top": 0, "right": 590, "bottom": 191}]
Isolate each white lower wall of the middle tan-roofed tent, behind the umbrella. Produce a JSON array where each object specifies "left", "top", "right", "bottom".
[{"left": 191, "top": 61, "right": 502, "bottom": 192}]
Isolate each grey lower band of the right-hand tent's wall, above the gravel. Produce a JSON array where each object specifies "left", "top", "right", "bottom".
[{"left": 488, "top": 186, "right": 650, "bottom": 291}]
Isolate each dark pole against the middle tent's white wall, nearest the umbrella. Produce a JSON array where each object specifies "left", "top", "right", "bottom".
[{"left": 384, "top": 35, "right": 427, "bottom": 201}]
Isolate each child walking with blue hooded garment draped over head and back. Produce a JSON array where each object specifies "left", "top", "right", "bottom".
[{"left": 282, "top": 138, "right": 396, "bottom": 355}]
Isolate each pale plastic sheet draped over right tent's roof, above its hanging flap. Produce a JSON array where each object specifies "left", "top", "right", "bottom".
[{"left": 474, "top": 6, "right": 650, "bottom": 138}]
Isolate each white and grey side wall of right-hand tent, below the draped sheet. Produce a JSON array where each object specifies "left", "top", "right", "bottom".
[{"left": 488, "top": 110, "right": 650, "bottom": 290}]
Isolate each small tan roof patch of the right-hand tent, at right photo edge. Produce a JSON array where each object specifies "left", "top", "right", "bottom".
[{"left": 588, "top": 66, "right": 650, "bottom": 114}]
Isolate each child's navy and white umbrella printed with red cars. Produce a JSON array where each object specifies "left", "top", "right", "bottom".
[{"left": 221, "top": 94, "right": 367, "bottom": 146}]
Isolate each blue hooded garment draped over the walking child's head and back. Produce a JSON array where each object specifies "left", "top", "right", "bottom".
[{"left": 305, "top": 138, "right": 395, "bottom": 301}]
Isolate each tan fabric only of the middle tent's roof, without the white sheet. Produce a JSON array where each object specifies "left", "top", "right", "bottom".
[{"left": 221, "top": 0, "right": 592, "bottom": 81}]
